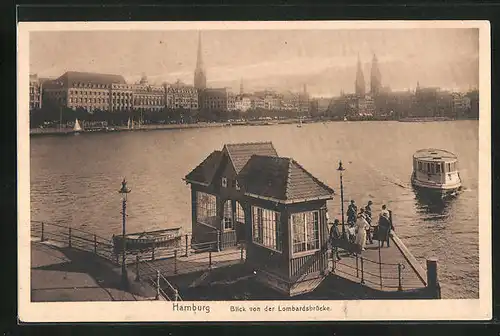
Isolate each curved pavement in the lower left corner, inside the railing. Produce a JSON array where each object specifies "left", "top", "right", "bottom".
[{"left": 31, "top": 241, "right": 160, "bottom": 302}]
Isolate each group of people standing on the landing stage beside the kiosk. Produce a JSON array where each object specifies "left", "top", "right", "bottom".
[{"left": 330, "top": 200, "right": 394, "bottom": 260}]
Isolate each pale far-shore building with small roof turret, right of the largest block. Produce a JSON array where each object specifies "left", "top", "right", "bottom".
[{"left": 132, "top": 76, "right": 165, "bottom": 111}]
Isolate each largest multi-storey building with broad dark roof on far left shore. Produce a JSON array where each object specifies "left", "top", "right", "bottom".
[{"left": 43, "top": 71, "right": 126, "bottom": 112}]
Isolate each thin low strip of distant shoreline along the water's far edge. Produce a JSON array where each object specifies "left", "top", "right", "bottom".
[{"left": 30, "top": 117, "right": 478, "bottom": 136}]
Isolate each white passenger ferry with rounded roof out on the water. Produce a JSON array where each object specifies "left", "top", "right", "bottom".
[{"left": 411, "top": 148, "right": 462, "bottom": 196}]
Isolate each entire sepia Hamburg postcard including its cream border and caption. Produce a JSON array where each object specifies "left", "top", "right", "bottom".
[{"left": 18, "top": 21, "right": 492, "bottom": 322}]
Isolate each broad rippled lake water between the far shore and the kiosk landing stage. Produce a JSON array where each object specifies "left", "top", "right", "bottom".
[{"left": 31, "top": 121, "right": 479, "bottom": 298}]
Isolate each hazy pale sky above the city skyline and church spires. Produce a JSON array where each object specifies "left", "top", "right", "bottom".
[{"left": 30, "top": 28, "right": 479, "bottom": 97}]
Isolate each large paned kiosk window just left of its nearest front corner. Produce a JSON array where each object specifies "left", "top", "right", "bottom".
[{"left": 252, "top": 206, "right": 283, "bottom": 252}]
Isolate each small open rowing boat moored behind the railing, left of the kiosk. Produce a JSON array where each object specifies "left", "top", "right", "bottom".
[{"left": 113, "top": 227, "right": 182, "bottom": 252}]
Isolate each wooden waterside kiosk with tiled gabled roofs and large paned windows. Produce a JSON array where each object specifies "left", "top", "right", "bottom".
[{"left": 185, "top": 142, "right": 334, "bottom": 296}]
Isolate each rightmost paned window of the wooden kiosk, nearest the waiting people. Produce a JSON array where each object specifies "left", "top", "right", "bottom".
[{"left": 291, "top": 211, "right": 319, "bottom": 253}]
